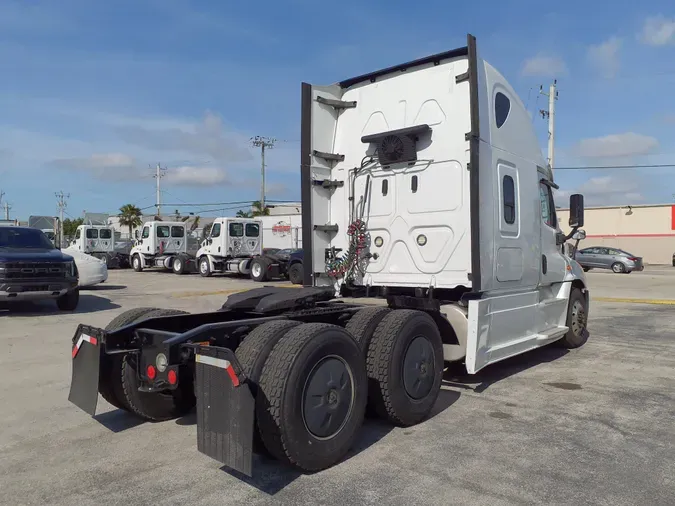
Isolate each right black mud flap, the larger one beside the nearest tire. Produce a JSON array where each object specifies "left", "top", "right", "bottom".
[{"left": 194, "top": 346, "right": 255, "bottom": 476}]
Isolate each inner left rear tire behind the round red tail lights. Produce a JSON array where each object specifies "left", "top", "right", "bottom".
[{"left": 114, "top": 309, "right": 196, "bottom": 422}]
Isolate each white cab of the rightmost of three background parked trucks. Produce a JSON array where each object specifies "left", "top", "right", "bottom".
[{"left": 197, "top": 218, "right": 262, "bottom": 277}]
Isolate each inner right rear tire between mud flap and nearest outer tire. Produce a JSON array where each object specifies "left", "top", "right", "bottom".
[{"left": 236, "top": 320, "right": 300, "bottom": 454}]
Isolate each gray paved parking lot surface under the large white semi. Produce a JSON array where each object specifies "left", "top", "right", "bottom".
[{"left": 0, "top": 267, "right": 675, "bottom": 506}]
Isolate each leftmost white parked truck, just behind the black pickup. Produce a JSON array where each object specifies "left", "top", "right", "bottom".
[{"left": 66, "top": 225, "right": 130, "bottom": 269}]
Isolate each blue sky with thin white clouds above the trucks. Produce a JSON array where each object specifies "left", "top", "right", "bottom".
[{"left": 0, "top": 0, "right": 675, "bottom": 219}]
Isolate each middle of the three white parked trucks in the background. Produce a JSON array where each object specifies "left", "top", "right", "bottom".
[{"left": 129, "top": 221, "right": 199, "bottom": 274}]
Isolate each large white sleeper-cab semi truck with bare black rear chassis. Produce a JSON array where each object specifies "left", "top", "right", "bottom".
[{"left": 69, "top": 35, "right": 590, "bottom": 475}]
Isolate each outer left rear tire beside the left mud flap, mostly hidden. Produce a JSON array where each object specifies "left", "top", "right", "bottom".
[{"left": 98, "top": 307, "right": 158, "bottom": 411}]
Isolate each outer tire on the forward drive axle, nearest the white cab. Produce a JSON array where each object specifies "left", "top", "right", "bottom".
[{"left": 366, "top": 309, "right": 443, "bottom": 427}]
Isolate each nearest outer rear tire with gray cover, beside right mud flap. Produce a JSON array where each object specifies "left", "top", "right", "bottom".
[{"left": 256, "top": 323, "right": 367, "bottom": 471}]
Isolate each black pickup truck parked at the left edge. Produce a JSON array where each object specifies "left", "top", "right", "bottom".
[{"left": 0, "top": 227, "right": 80, "bottom": 311}]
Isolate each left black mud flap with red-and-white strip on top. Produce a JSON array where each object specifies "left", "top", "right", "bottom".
[{"left": 68, "top": 325, "right": 105, "bottom": 416}]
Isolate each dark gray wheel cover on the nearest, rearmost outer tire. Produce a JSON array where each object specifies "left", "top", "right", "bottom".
[{"left": 302, "top": 355, "right": 354, "bottom": 439}]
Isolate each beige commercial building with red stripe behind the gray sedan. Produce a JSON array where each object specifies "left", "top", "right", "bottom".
[{"left": 557, "top": 204, "right": 675, "bottom": 265}]
